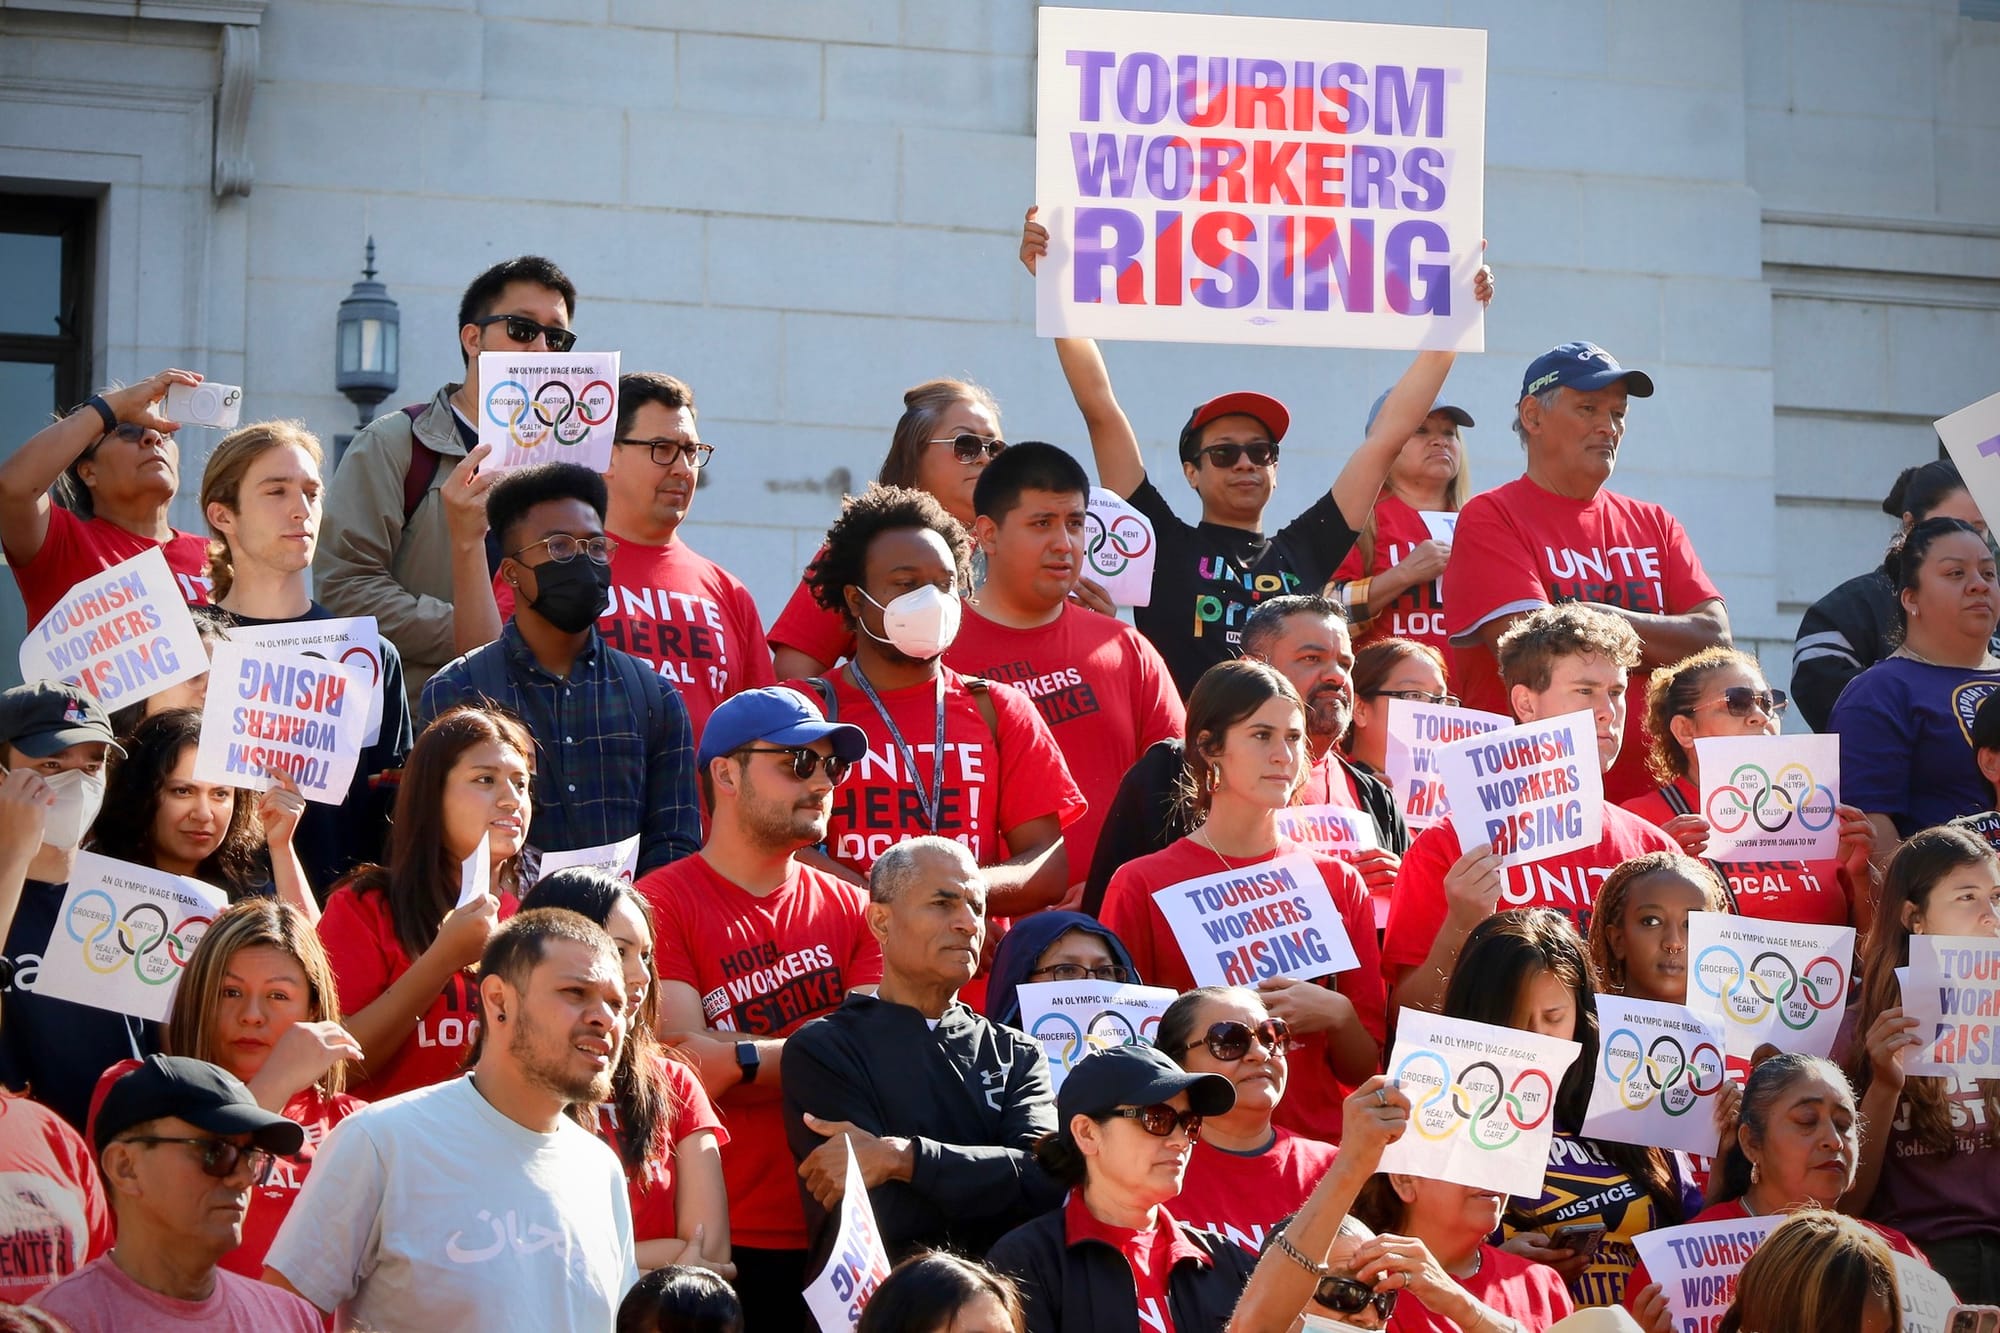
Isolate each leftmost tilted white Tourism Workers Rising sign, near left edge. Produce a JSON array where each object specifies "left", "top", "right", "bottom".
[{"left": 20, "top": 546, "right": 208, "bottom": 711}]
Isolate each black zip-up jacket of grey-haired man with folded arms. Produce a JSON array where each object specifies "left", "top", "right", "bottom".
[{"left": 784, "top": 995, "right": 1064, "bottom": 1261}]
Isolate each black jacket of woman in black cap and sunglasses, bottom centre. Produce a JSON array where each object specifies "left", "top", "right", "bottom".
[{"left": 992, "top": 1200, "right": 1256, "bottom": 1333}]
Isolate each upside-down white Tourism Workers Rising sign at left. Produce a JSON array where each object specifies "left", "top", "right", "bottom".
[{"left": 194, "top": 640, "right": 370, "bottom": 805}]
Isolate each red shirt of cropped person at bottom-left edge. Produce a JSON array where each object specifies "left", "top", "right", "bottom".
[{"left": 0, "top": 1091, "right": 112, "bottom": 1305}]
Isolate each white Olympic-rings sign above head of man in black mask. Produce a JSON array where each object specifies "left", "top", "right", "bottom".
[{"left": 480, "top": 350, "right": 618, "bottom": 472}]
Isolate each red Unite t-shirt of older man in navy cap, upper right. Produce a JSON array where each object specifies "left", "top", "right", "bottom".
[{"left": 1444, "top": 476, "right": 1722, "bottom": 801}]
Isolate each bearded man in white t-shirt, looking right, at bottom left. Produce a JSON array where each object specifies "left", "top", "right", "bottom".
[{"left": 264, "top": 909, "right": 638, "bottom": 1329}]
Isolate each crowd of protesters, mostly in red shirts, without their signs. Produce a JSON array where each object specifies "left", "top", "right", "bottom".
[{"left": 0, "top": 239, "right": 2000, "bottom": 1333}]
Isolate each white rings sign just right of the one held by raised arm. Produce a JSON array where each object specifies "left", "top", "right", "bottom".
[{"left": 1584, "top": 993, "right": 1728, "bottom": 1157}]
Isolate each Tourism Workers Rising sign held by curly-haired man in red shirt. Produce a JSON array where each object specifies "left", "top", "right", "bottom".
[{"left": 1438, "top": 713, "right": 1604, "bottom": 867}]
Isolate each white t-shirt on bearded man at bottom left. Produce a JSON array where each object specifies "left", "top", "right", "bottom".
[{"left": 266, "top": 1077, "right": 638, "bottom": 1329}]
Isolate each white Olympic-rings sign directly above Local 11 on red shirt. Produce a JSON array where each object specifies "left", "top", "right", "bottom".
[{"left": 1694, "top": 737, "right": 1840, "bottom": 861}]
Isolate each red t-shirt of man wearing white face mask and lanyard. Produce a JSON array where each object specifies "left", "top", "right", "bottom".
[{"left": 790, "top": 667, "right": 1084, "bottom": 875}]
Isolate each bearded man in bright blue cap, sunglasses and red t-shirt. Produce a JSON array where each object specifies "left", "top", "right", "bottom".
[{"left": 638, "top": 687, "right": 882, "bottom": 1329}]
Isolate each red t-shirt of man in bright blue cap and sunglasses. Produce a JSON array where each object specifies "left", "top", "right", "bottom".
[{"left": 638, "top": 852, "right": 882, "bottom": 1249}]
